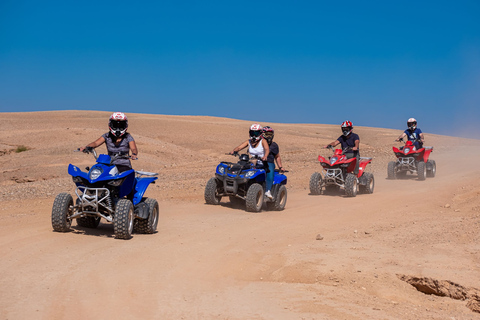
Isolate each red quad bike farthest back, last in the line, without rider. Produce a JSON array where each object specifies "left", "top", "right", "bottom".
[{"left": 387, "top": 139, "right": 437, "bottom": 180}]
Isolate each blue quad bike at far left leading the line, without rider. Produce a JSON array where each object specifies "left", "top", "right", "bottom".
[{"left": 52, "top": 148, "right": 159, "bottom": 239}]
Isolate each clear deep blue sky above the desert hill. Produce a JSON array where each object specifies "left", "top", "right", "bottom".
[{"left": 0, "top": 0, "right": 480, "bottom": 138}]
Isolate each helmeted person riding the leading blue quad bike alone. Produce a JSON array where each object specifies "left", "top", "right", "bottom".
[{"left": 79, "top": 112, "right": 138, "bottom": 172}]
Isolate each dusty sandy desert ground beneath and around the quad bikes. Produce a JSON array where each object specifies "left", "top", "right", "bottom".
[{"left": 0, "top": 111, "right": 480, "bottom": 320}]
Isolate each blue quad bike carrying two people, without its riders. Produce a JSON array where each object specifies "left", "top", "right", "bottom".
[{"left": 205, "top": 153, "right": 287, "bottom": 212}]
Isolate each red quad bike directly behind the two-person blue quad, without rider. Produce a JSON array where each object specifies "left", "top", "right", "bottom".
[{"left": 310, "top": 146, "right": 375, "bottom": 197}]
